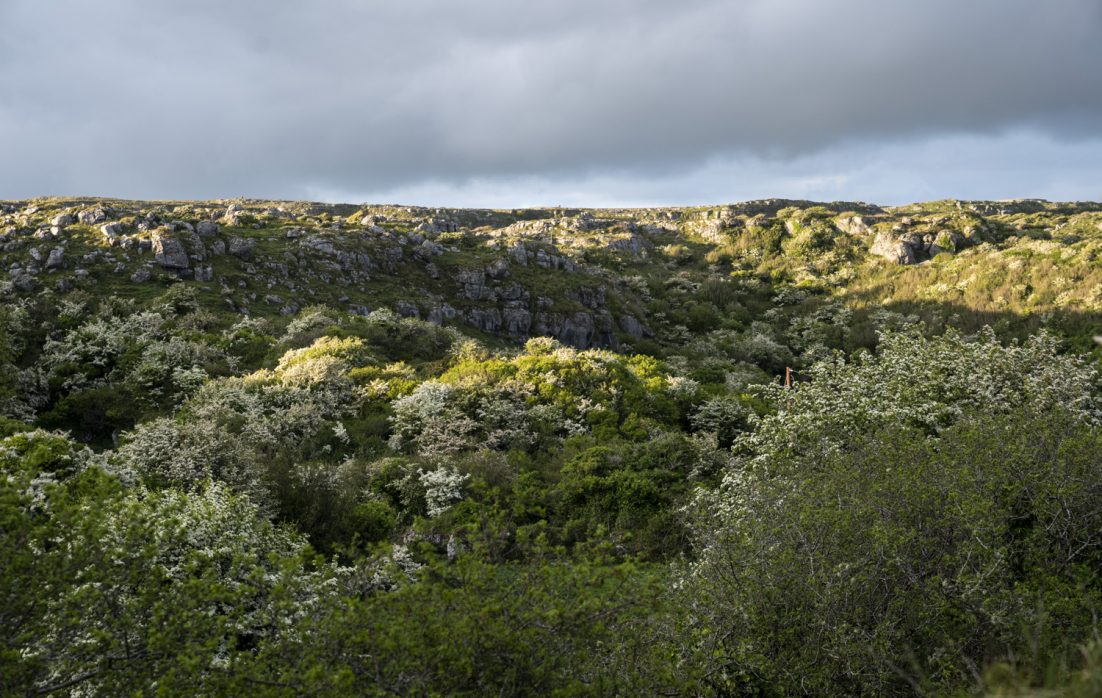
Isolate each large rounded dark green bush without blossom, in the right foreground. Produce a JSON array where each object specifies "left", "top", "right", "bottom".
[{"left": 685, "top": 412, "right": 1102, "bottom": 695}]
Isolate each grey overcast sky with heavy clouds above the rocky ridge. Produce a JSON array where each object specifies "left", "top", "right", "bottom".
[{"left": 0, "top": 0, "right": 1102, "bottom": 206}]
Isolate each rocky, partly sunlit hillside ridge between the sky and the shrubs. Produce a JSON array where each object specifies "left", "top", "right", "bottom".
[{"left": 0, "top": 198, "right": 1102, "bottom": 348}]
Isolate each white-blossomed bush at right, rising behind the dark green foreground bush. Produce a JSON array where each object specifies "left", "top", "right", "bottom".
[{"left": 736, "top": 329, "right": 1102, "bottom": 474}]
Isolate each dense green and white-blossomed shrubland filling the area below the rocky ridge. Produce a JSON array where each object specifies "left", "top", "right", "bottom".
[{"left": 0, "top": 195, "right": 1102, "bottom": 696}]
